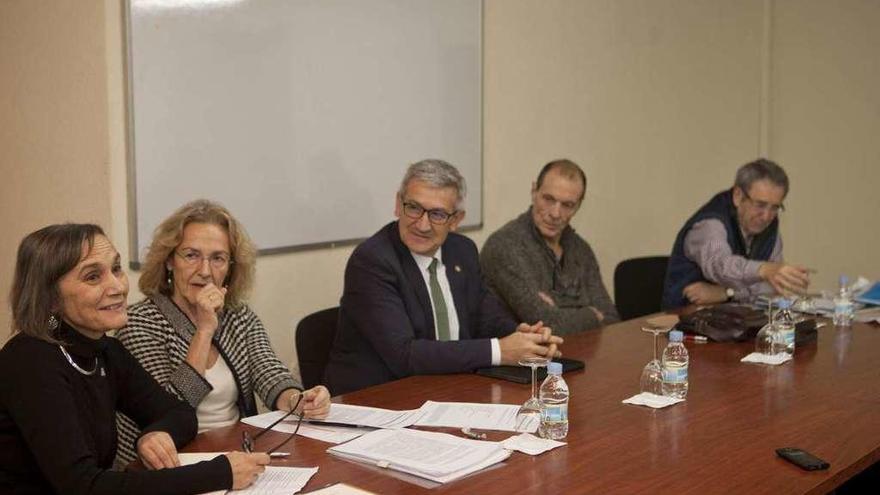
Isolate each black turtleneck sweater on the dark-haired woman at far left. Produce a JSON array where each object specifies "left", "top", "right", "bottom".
[{"left": 0, "top": 325, "right": 232, "bottom": 494}]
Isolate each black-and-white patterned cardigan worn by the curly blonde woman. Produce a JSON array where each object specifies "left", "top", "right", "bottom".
[{"left": 116, "top": 295, "right": 302, "bottom": 462}]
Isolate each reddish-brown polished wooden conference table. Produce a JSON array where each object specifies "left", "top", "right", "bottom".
[{"left": 185, "top": 319, "right": 880, "bottom": 495}]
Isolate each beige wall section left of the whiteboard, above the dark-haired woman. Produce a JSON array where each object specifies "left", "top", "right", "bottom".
[{"left": 0, "top": 0, "right": 111, "bottom": 343}]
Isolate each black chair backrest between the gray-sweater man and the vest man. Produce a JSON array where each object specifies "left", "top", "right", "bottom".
[{"left": 614, "top": 256, "right": 669, "bottom": 320}]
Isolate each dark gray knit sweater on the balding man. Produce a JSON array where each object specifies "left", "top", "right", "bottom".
[{"left": 480, "top": 209, "right": 620, "bottom": 335}]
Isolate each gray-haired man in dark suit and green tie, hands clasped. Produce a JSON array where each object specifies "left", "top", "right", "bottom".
[{"left": 325, "top": 160, "right": 562, "bottom": 395}]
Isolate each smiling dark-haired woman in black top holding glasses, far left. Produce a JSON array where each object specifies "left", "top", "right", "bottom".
[{"left": 0, "top": 224, "right": 269, "bottom": 494}]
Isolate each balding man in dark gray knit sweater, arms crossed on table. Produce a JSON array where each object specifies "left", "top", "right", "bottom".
[{"left": 480, "top": 160, "right": 620, "bottom": 335}]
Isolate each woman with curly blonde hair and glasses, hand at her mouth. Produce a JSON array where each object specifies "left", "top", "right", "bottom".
[{"left": 117, "top": 200, "right": 330, "bottom": 460}]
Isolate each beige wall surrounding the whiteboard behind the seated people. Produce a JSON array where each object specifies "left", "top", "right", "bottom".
[{"left": 0, "top": 0, "right": 880, "bottom": 382}]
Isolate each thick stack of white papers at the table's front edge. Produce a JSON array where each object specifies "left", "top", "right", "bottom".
[{"left": 327, "top": 429, "right": 510, "bottom": 483}]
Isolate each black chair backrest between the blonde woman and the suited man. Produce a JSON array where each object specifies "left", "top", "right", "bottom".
[{"left": 296, "top": 306, "right": 339, "bottom": 389}]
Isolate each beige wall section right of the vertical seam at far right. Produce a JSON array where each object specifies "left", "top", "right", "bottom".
[{"left": 769, "top": 0, "right": 880, "bottom": 288}]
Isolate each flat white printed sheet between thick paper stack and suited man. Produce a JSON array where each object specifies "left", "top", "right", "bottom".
[{"left": 416, "top": 400, "right": 538, "bottom": 433}]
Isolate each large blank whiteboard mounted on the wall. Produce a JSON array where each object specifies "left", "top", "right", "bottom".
[{"left": 127, "top": 0, "right": 482, "bottom": 264}]
